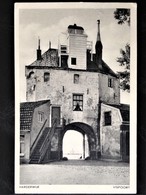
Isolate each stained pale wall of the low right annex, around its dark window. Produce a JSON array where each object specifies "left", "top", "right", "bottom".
[{"left": 100, "top": 104, "right": 122, "bottom": 158}]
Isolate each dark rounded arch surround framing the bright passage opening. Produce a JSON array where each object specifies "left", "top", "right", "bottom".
[{"left": 58, "top": 122, "right": 97, "bottom": 160}]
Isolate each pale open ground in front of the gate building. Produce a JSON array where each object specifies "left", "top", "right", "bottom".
[{"left": 20, "top": 160, "right": 129, "bottom": 185}]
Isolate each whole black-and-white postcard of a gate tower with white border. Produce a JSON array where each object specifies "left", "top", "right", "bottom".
[{"left": 15, "top": 2, "right": 137, "bottom": 194}]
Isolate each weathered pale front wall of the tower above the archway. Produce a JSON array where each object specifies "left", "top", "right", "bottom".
[{"left": 27, "top": 68, "right": 99, "bottom": 134}]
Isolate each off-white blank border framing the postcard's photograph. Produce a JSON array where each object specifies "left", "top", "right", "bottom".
[{"left": 14, "top": 2, "right": 137, "bottom": 194}]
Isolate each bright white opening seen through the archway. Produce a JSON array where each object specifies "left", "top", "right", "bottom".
[{"left": 63, "top": 130, "right": 89, "bottom": 160}]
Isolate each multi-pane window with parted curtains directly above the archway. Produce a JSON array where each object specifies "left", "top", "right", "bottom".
[{"left": 73, "top": 94, "right": 83, "bottom": 111}]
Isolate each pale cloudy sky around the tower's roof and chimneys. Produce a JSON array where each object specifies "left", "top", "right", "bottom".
[{"left": 18, "top": 5, "right": 130, "bottom": 103}]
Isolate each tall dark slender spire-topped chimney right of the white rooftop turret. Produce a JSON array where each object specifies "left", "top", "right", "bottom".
[{"left": 95, "top": 20, "right": 103, "bottom": 69}]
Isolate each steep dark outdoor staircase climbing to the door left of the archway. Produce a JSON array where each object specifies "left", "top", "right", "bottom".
[{"left": 29, "top": 127, "right": 51, "bottom": 164}]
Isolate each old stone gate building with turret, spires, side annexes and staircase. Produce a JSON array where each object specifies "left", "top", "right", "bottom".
[{"left": 20, "top": 20, "right": 129, "bottom": 163}]
